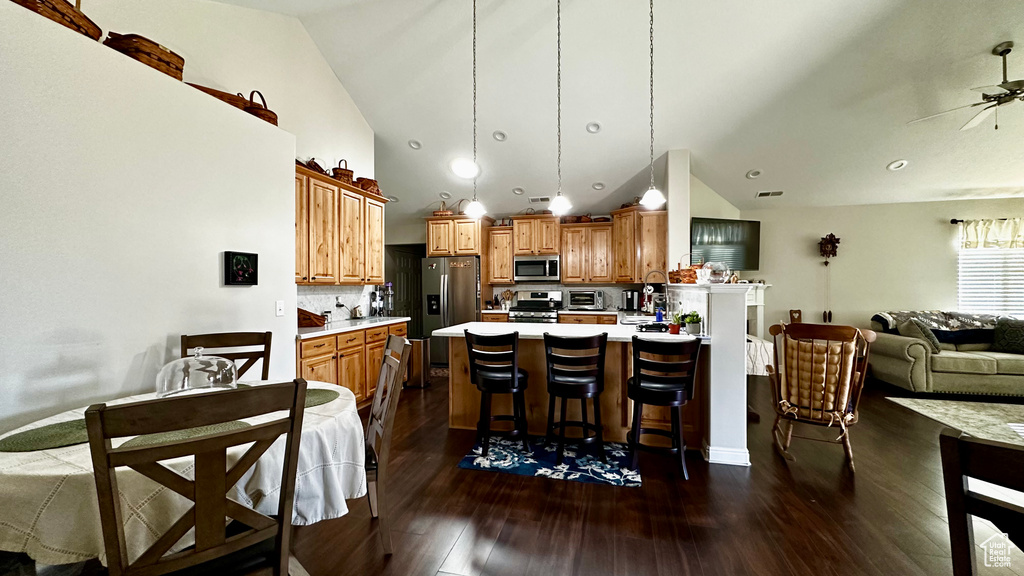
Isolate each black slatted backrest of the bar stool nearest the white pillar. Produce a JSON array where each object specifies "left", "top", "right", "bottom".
[{"left": 633, "top": 336, "right": 700, "bottom": 400}]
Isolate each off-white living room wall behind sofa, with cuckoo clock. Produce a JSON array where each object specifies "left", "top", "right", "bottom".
[{"left": 742, "top": 198, "right": 1024, "bottom": 327}]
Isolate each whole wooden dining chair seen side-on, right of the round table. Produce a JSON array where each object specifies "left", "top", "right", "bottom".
[{"left": 366, "top": 334, "right": 413, "bottom": 554}]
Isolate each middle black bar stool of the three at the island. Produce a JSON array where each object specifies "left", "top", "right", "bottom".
[{"left": 544, "top": 332, "right": 608, "bottom": 464}]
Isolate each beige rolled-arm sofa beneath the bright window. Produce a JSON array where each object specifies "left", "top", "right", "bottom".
[{"left": 869, "top": 332, "right": 1024, "bottom": 396}]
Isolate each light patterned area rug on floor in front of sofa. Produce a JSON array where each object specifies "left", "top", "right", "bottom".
[{"left": 889, "top": 398, "right": 1024, "bottom": 446}]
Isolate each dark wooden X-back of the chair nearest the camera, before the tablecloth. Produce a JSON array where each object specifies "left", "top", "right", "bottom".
[{"left": 85, "top": 379, "right": 306, "bottom": 576}]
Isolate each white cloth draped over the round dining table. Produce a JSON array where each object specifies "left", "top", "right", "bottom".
[{"left": 0, "top": 381, "right": 367, "bottom": 565}]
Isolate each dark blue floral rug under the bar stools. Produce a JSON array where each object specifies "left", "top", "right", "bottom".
[{"left": 459, "top": 438, "right": 640, "bottom": 488}]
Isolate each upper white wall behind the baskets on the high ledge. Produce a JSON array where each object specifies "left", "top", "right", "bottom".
[{"left": 83, "top": 0, "right": 374, "bottom": 177}]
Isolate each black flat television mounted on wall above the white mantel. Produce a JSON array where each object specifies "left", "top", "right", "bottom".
[{"left": 690, "top": 218, "right": 761, "bottom": 271}]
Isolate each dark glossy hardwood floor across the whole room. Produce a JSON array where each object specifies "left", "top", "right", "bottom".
[{"left": 294, "top": 378, "right": 1024, "bottom": 576}]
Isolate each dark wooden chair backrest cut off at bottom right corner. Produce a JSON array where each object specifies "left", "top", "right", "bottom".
[{"left": 939, "top": 428, "right": 1024, "bottom": 576}]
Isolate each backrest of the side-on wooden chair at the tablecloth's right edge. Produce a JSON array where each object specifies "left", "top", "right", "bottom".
[{"left": 366, "top": 334, "right": 413, "bottom": 475}]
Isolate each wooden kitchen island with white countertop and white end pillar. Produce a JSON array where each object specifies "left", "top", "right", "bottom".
[{"left": 433, "top": 284, "right": 750, "bottom": 466}]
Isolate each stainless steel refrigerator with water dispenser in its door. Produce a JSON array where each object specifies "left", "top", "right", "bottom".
[{"left": 423, "top": 256, "right": 480, "bottom": 364}]
